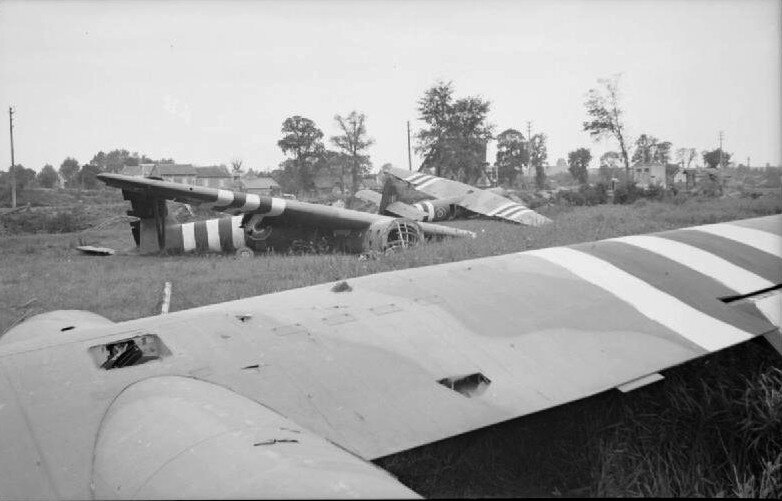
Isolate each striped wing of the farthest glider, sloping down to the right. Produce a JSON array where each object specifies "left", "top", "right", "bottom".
[{"left": 386, "top": 167, "right": 550, "bottom": 226}]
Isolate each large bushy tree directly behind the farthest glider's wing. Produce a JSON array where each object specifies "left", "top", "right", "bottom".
[{"left": 415, "top": 82, "right": 493, "bottom": 183}]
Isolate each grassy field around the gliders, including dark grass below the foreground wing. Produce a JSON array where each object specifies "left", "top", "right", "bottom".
[{"left": 0, "top": 195, "right": 782, "bottom": 497}]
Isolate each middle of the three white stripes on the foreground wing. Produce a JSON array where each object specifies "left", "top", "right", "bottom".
[{"left": 611, "top": 235, "right": 775, "bottom": 294}]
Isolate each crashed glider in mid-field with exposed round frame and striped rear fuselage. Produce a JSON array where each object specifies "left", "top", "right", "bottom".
[{"left": 98, "top": 174, "right": 475, "bottom": 253}]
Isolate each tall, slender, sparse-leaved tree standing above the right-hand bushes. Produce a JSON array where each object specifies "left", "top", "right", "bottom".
[{"left": 583, "top": 75, "right": 630, "bottom": 177}]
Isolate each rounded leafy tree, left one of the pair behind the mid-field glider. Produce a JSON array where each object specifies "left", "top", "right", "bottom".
[{"left": 277, "top": 115, "right": 324, "bottom": 190}]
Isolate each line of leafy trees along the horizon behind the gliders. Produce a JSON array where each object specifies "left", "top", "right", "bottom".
[{"left": 0, "top": 77, "right": 760, "bottom": 198}]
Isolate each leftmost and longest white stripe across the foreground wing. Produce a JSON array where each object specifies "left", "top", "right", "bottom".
[{"left": 525, "top": 247, "right": 752, "bottom": 351}]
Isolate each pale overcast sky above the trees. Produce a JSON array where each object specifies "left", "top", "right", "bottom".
[{"left": 0, "top": 0, "right": 782, "bottom": 170}]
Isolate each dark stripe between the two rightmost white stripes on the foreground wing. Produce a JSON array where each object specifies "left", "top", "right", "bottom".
[{"left": 658, "top": 230, "right": 782, "bottom": 284}]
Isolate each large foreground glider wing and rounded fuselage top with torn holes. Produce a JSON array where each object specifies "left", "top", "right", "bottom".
[{"left": 0, "top": 215, "right": 782, "bottom": 499}]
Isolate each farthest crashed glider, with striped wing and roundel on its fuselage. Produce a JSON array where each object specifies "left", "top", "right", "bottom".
[{"left": 366, "top": 167, "right": 550, "bottom": 226}]
